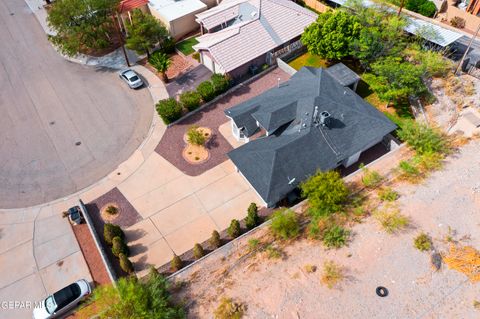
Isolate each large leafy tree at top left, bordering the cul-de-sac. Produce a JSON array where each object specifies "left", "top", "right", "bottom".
[{"left": 47, "top": 0, "right": 120, "bottom": 56}]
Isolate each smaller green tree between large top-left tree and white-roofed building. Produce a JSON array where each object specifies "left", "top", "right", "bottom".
[{"left": 125, "top": 9, "right": 168, "bottom": 57}]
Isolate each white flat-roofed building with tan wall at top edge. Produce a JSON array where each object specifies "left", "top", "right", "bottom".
[{"left": 148, "top": 0, "right": 217, "bottom": 40}]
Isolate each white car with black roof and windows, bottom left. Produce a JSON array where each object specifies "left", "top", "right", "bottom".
[{"left": 33, "top": 279, "right": 92, "bottom": 319}]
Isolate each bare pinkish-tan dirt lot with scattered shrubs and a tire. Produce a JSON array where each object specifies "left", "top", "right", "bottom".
[{"left": 176, "top": 141, "right": 480, "bottom": 318}]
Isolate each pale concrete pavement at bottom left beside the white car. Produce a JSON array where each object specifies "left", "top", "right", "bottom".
[{"left": 0, "top": 208, "right": 92, "bottom": 319}]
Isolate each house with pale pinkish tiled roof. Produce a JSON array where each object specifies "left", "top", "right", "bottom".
[{"left": 193, "top": 0, "right": 317, "bottom": 78}]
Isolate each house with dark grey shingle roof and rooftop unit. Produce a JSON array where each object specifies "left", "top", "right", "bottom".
[{"left": 225, "top": 64, "right": 396, "bottom": 207}]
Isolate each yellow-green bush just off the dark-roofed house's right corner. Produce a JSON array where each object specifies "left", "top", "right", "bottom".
[{"left": 397, "top": 120, "right": 448, "bottom": 155}]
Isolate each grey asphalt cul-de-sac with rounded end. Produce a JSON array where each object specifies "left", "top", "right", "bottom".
[{"left": 0, "top": 0, "right": 153, "bottom": 208}]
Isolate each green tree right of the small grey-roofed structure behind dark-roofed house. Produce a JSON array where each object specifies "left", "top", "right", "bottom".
[{"left": 364, "top": 57, "right": 427, "bottom": 101}]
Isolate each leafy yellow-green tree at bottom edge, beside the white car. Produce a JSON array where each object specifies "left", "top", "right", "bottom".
[{"left": 79, "top": 272, "right": 185, "bottom": 319}]
